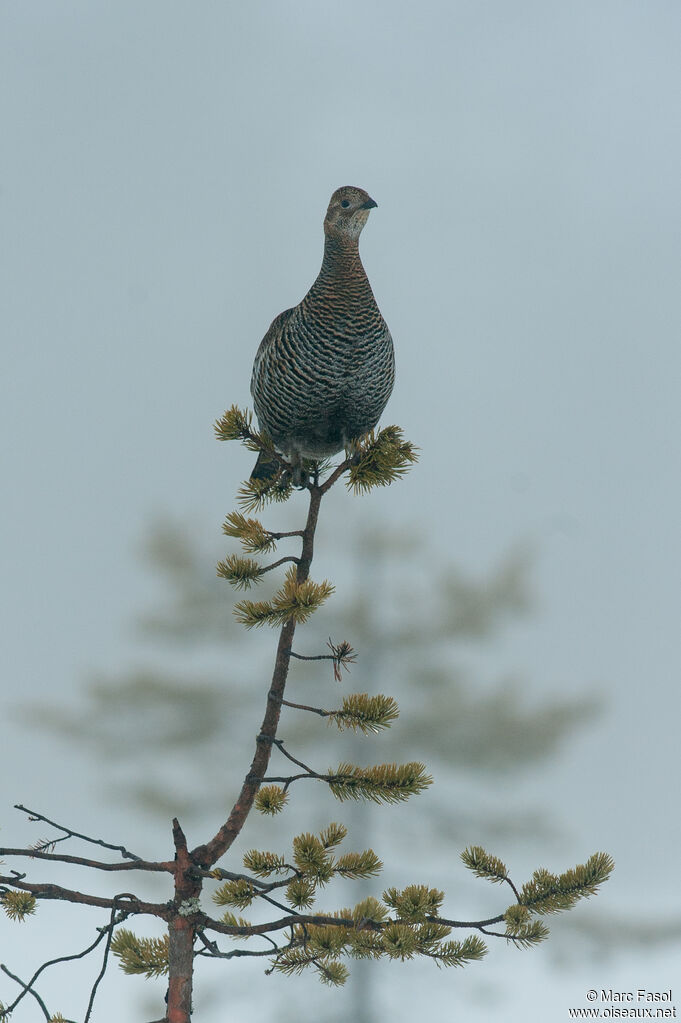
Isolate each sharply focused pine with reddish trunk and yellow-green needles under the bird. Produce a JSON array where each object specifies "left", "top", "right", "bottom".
[{"left": 0, "top": 407, "right": 612, "bottom": 1023}]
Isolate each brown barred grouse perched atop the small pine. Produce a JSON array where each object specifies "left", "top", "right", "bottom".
[{"left": 251, "top": 185, "right": 395, "bottom": 486}]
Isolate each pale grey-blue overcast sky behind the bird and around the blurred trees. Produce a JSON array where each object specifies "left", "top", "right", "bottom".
[{"left": 0, "top": 0, "right": 681, "bottom": 1023}]
